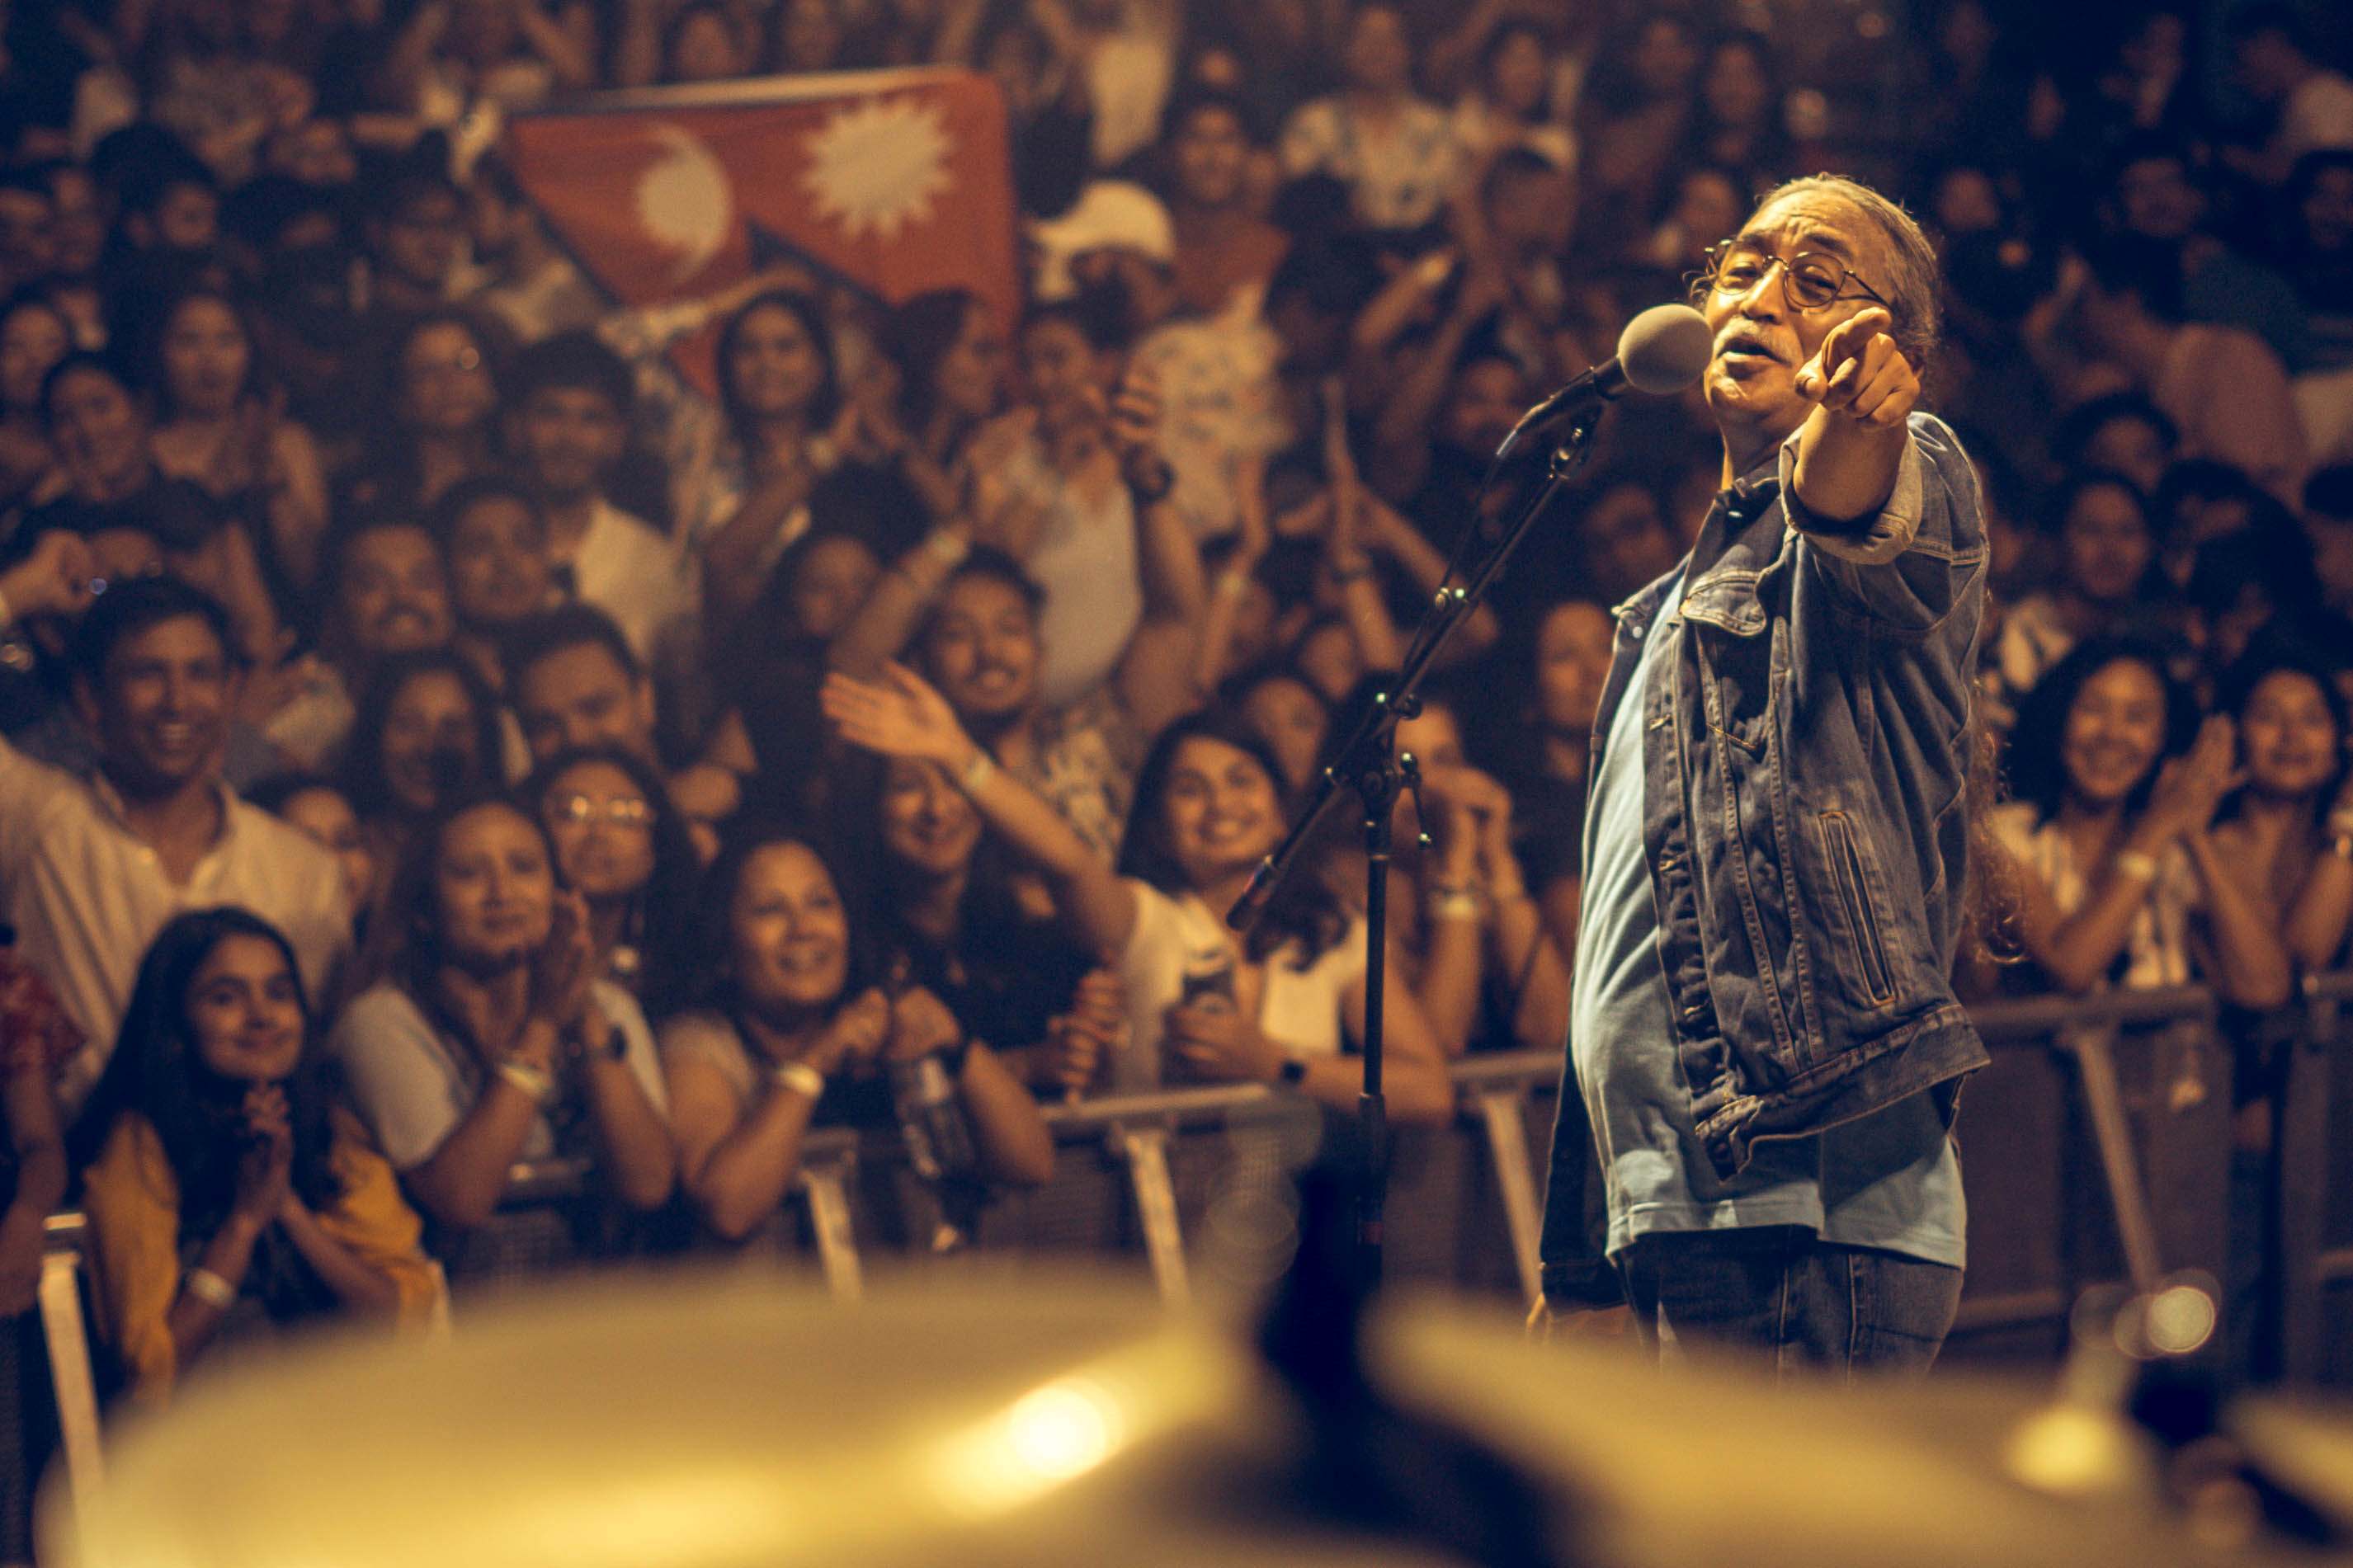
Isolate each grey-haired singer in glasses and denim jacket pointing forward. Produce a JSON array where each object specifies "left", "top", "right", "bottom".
[{"left": 1539, "top": 177, "right": 1986, "bottom": 1373}]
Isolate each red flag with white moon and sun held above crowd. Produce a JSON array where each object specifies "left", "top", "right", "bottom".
[{"left": 506, "top": 71, "right": 1019, "bottom": 392}]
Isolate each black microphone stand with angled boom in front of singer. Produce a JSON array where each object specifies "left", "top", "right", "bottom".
[{"left": 1226, "top": 402, "right": 1607, "bottom": 1288}]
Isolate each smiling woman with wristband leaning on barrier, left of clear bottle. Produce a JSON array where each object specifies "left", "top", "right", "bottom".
[{"left": 661, "top": 825, "right": 1054, "bottom": 1241}]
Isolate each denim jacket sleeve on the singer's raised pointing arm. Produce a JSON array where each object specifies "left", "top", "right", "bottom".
[{"left": 1781, "top": 414, "right": 1986, "bottom": 633}]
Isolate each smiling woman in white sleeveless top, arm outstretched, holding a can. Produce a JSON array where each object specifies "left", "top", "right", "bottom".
[{"left": 823, "top": 666, "right": 1455, "bottom": 1121}]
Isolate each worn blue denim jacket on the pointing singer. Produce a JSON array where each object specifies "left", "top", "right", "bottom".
[{"left": 1541, "top": 414, "right": 1986, "bottom": 1300}]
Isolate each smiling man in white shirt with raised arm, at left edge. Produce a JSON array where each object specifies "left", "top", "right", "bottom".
[{"left": 0, "top": 545, "right": 351, "bottom": 1109}]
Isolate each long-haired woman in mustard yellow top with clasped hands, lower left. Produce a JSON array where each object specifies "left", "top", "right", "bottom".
[{"left": 73, "top": 907, "right": 440, "bottom": 1403}]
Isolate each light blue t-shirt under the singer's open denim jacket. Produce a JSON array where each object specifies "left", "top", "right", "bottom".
[{"left": 1569, "top": 576, "right": 1964, "bottom": 1267}]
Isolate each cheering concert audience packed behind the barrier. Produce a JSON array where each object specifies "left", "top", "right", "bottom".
[{"left": 0, "top": 0, "right": 2353, "bottom": 1399}]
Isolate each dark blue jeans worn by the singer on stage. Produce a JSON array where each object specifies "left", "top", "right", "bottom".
[{"left": 1616, "top": 1225, "right": 1960, "bottom": 1377}]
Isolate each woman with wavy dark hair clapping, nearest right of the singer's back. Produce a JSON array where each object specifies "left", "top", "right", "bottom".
[{"left": 1991, "top": 637, "right": 2289, "bottom": 1006}]
